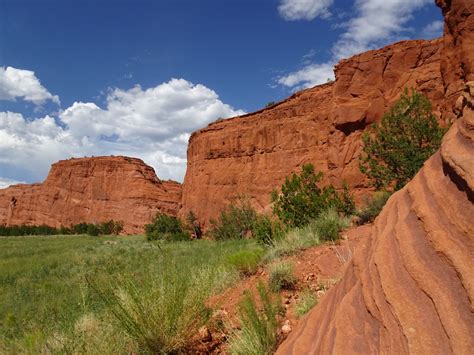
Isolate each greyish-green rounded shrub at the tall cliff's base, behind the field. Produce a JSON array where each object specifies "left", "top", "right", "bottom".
[{"left": 210, "top": 198, "right": 257, "bottom": 240}]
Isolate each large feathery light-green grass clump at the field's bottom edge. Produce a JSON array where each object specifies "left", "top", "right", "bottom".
[{"left": 94, "top": 262, "right": 210, "bottom": 354}]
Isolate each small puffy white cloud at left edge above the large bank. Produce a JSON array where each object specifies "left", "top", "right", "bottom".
[{"left": 0, "top": 67, "right": 59, "bottom": 105}]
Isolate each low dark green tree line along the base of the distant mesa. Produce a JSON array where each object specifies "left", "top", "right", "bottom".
[{"left": 0, "top": 220, "right": 123, "bottom": 236}]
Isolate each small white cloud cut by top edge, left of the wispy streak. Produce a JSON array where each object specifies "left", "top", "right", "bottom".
[{"left": 278, "top": 0, "right": 334, "bottom": 21}]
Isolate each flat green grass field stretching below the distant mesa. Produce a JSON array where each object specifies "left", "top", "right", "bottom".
[{"left": 0, "top": 236, "right": 258, "bottom": 354}]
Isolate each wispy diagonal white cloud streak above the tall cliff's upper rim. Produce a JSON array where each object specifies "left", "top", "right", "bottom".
[{"left": 277, "top": 0, "right": 431, "bottom": 89}]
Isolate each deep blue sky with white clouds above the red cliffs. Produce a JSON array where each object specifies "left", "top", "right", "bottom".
[{"left": 0, "top": 0, "right": 442, "bottom": 187}]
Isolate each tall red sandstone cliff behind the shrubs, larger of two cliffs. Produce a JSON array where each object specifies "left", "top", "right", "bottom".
[{"left": 181, "top": 40, "right": 444, "bottom": 221}]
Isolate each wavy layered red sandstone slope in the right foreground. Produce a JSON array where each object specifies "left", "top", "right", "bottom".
[{"left": 277, "top": 0, "right": 474, "bottom": 354}]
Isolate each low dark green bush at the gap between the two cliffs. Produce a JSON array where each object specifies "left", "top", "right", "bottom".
[{"left": 145, "top": 212, "right": 191, "bottom": 241}]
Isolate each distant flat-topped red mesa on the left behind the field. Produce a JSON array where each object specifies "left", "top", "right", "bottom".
[{"left": 0, "top": 157, "right": 181, "bottom": 233}]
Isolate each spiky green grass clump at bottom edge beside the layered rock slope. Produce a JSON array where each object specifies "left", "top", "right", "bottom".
[{"left": 229, "top": 282, "right": 281, "bottom": 355}]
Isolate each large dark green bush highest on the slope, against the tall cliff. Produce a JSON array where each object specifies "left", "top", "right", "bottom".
[{"left": 360, "top": 89, "right": 447, "bottom": 190}]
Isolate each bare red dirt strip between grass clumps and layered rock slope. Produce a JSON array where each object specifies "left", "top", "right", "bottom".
[{"left": 193, "top": 226, "right": 370, "bottom": 353}]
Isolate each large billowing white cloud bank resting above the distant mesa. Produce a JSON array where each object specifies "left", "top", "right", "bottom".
[{"left": 0, "top": 79, "right": 244, "bottom": 184}]
